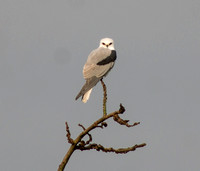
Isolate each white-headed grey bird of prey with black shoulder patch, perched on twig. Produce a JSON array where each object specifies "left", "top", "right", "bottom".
[{"left": 75, "top": 38, "right": 117, "bottom": 103}]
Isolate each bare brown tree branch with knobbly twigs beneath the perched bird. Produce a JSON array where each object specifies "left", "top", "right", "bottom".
[{"left": 58, "top": 80, "right": 146, "bottom": 171}]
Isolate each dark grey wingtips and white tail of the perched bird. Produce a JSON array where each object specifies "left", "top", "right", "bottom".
[{"left": 75, "top": 76, "right": 101, "bottom": 103}]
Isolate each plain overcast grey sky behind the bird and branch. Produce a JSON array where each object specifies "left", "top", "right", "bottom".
[{"left": 0, "top": 0, "right": 200, "bottom": 171}]
